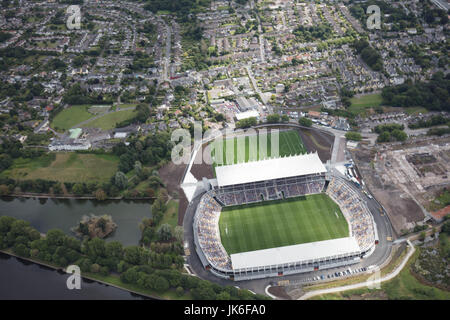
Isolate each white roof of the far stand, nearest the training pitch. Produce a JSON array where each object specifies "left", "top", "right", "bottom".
[{"left": 216, "top": 153, "right": 327, "bottom": 187}]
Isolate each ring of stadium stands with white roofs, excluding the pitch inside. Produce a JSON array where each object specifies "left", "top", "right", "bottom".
[{"left": 194, "top": 153, "right": 376, "bottom": 280}]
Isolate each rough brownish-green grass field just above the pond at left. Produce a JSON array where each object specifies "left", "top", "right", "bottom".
[{"left": 2, "top": 153, "right": 119, "bottom": 182}]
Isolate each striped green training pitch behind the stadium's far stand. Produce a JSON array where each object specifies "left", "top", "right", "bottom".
[{"left": 211, "top": 130, "right": 306, "bottom": 167}]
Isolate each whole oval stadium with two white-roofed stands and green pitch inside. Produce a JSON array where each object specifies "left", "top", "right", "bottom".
[{"left": 193, "top": 129, "right": 378, "bottom": 281}]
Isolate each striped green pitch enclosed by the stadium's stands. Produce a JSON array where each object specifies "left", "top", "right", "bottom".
[{"left": 219, "top": 194, "right": 349, "bottom": 254}]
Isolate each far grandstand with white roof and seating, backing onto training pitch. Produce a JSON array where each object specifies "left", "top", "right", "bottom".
[{"left": 214, "top": 153, "right": 326, "bottom": 206}]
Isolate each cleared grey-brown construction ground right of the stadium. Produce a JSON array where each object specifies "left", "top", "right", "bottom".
[{"left": 352, "top": 137, "right": 450, "bottom": 235}]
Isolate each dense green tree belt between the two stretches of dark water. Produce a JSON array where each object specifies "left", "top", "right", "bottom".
[{"left": 0, "top": 216, "right": 267, "bottom": 300}]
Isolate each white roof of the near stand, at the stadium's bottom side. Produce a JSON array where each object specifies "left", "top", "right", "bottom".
[{"left": 230, "top": 237, "right": 360, "bottom": 270}]
